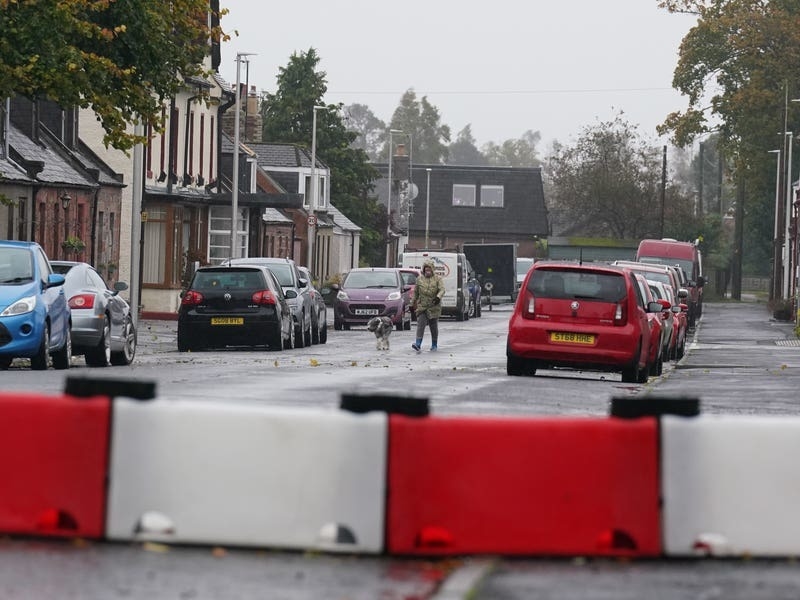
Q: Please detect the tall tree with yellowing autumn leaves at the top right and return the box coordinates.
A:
[659,0,800,272]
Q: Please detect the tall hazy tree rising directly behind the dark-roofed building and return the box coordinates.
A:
[383,89,450,164]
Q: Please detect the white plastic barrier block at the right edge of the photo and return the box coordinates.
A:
[661,415,800,556]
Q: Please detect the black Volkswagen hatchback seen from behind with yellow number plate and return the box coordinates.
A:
[178,265,295,352]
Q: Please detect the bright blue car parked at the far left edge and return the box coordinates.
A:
[0,240,72,370]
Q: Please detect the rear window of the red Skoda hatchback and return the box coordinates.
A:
[527,269,626,302]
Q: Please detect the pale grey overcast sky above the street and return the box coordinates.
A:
[220,0,695,153]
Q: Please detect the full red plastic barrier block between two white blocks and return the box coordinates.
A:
[386,415,661,556]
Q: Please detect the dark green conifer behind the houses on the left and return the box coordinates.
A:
[261,48,386,264]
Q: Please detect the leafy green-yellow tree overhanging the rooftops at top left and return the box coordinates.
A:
[0,0,227,150]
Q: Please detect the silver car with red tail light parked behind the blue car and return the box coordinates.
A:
[50,260,136,367]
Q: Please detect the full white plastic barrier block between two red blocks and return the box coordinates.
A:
[106,399,388,553]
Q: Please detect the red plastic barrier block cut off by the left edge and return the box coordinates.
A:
[0,393,111,538]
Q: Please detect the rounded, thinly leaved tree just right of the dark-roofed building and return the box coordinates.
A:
[547,116,676,239]
